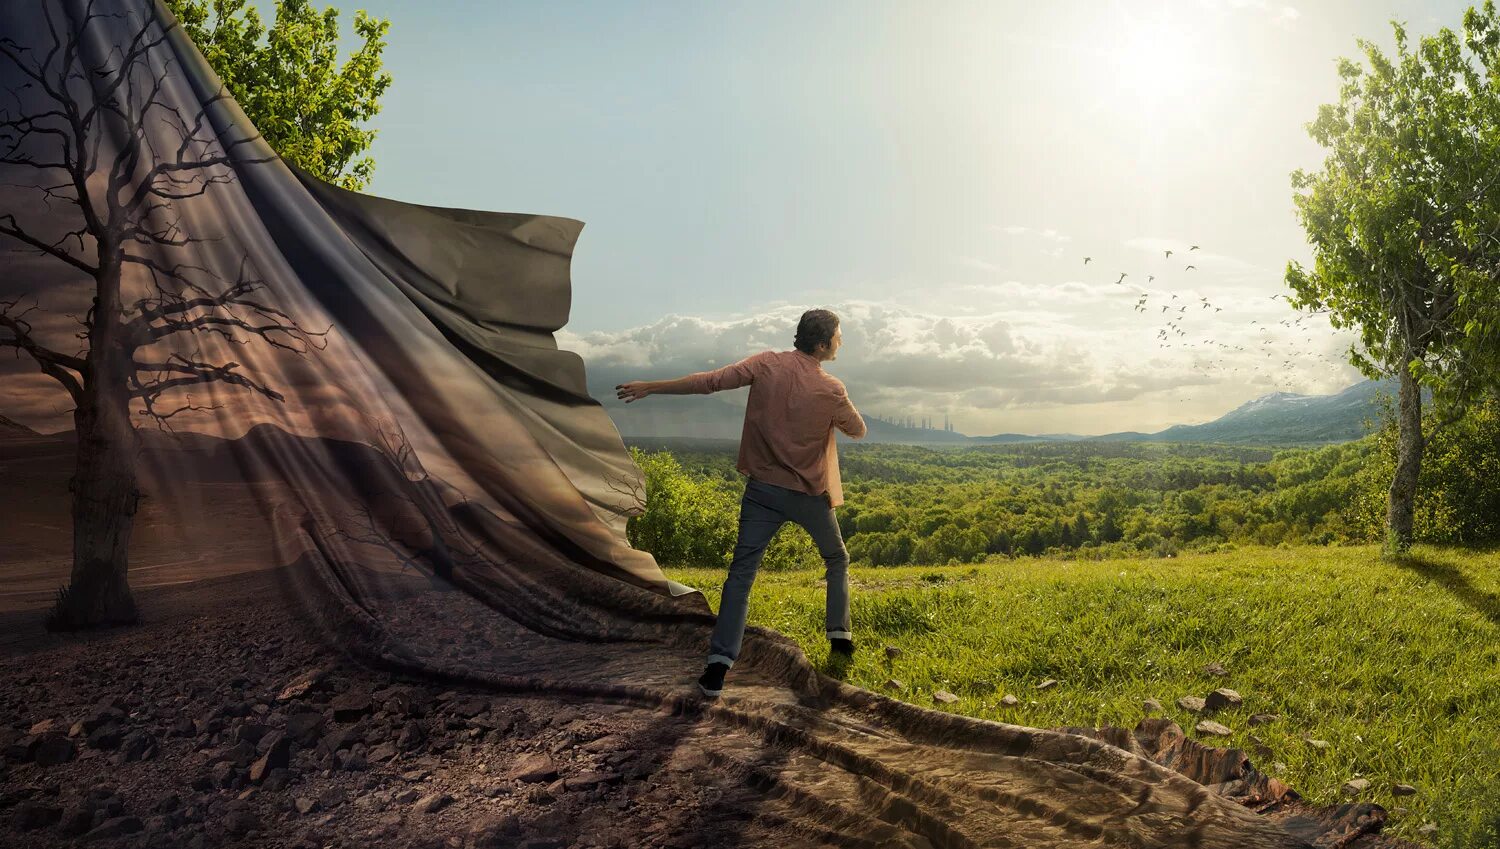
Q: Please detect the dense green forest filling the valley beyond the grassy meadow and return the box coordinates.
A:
[632,423,1500,569]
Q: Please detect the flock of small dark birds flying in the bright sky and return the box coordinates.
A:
[1083,245,1343,401]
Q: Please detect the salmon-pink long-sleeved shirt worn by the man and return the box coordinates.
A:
[687,350,866,507]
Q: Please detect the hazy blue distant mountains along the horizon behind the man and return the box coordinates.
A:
[605,380,1433,446]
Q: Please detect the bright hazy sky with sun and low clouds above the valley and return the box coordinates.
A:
[270,0,1469,435]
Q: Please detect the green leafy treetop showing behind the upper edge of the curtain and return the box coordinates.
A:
[167,0,392,189]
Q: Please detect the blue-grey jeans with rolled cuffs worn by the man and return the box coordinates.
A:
[708,479,851,666]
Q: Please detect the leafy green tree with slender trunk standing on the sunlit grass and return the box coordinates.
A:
[1286,0,1500,555]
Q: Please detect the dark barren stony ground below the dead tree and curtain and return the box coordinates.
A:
[0,573,846,849]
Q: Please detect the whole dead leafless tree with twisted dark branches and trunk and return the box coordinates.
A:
[0,0,327,629]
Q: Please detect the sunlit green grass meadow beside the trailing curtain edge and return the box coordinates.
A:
[668,546,1500,848]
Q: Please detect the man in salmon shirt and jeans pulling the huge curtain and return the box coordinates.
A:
[615,309,866,698]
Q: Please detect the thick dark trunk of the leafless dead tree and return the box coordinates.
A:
[47,264,141,630]
